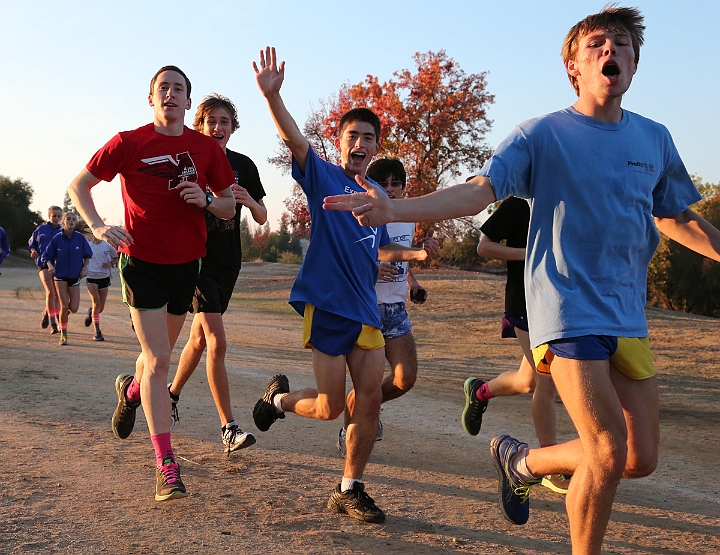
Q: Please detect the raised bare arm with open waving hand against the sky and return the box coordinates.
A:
[253,46,310,173]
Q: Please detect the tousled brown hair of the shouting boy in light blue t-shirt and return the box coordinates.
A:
[562,4,645,94]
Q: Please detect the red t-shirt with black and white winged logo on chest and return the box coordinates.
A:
[87,123,235,264]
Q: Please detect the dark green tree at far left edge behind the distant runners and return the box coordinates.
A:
[0,175,43,252]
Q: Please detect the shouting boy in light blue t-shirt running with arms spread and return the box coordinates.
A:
[325,5,720,553]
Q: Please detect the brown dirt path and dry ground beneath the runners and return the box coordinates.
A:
[0,264,720,555]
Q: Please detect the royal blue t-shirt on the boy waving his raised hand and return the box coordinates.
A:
[290,148,390,328]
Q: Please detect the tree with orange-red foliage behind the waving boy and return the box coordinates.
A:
[270,50,494,235]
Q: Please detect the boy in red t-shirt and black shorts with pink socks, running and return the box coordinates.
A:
[68,66,235,501]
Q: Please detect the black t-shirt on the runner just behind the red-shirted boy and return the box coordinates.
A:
[203,149,265,270]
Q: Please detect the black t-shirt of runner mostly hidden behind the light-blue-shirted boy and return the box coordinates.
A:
[480,197,530,318]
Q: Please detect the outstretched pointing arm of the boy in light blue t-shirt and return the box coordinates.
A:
[323,175,496,226]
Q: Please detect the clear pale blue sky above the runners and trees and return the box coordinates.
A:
[0,0,720,228]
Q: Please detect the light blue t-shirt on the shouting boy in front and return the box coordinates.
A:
[480,108,700,347]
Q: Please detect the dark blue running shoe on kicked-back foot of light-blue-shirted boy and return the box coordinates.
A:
[490,435,540,524]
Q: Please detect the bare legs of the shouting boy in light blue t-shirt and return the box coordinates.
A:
[516,356,659,555]
